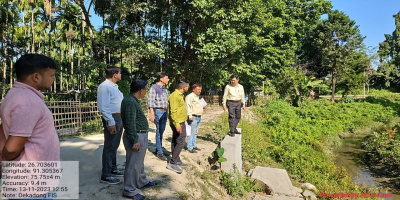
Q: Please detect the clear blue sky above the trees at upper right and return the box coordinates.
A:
[331,0,400,47]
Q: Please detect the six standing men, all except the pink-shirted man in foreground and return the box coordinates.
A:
[97,69,245,199]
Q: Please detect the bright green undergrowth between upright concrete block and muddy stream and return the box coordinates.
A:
[209,91,400,198]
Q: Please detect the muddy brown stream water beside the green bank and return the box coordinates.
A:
[334,135,400,200]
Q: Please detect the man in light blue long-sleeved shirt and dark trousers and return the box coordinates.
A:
[97,66,124,184]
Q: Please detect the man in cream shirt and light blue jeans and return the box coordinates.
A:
[185,83,203,153]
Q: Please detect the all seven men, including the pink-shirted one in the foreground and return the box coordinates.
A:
[0,54,245,199]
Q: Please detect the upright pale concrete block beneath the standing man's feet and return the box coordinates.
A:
[220,128,242,174]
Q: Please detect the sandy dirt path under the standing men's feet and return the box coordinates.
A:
[61,107,231,200]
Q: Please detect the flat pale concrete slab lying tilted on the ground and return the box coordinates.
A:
[251,166,297,197]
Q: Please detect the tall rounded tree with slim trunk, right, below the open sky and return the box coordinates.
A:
[302,10,368,101]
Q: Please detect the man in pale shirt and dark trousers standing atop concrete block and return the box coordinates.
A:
[222,75,245,137]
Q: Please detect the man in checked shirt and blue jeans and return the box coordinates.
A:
[147,72,169,161]
